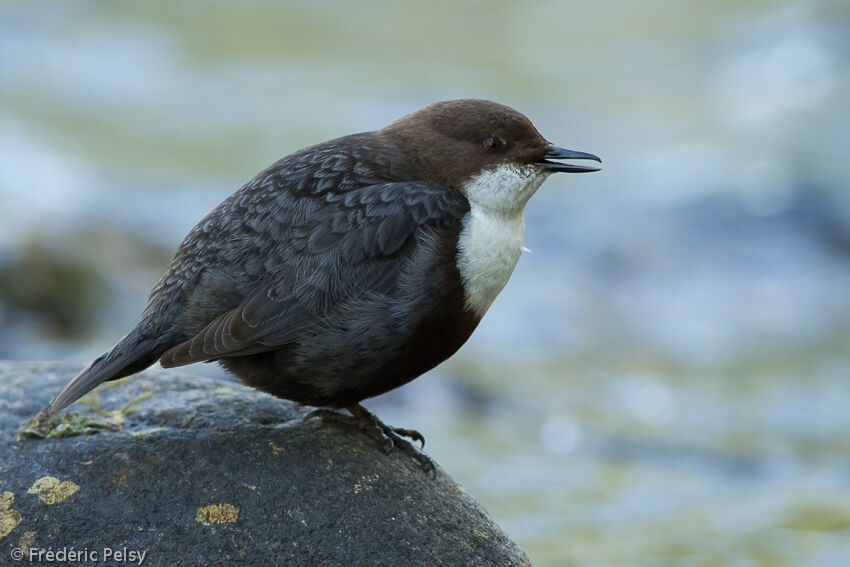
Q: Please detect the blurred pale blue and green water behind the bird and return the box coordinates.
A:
[0,0,850,567]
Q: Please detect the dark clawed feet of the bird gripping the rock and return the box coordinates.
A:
[304,404,437,478]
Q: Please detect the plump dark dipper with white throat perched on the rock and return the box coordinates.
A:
[47,99,601,474]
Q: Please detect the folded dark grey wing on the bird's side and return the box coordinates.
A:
[161,182,469,367]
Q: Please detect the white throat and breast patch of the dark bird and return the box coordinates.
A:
[457,164,548,317]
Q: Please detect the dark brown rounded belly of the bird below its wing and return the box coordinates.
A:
[220,286,480,407]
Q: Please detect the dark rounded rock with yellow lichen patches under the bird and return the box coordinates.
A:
[0,362,529,567]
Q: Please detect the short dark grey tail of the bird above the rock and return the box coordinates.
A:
[47,321,167,415]
